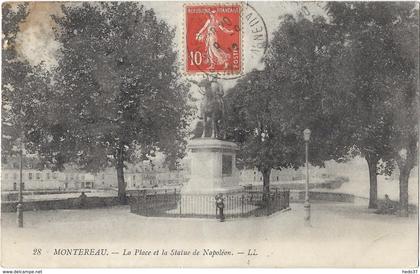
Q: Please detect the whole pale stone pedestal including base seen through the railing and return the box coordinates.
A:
[168,138,243,217]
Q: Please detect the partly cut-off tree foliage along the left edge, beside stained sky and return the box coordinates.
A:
[2,3,49,160]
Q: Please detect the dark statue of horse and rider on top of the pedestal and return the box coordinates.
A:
[189,78,226,139]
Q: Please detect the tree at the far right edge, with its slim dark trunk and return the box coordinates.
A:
[384,3,420,217]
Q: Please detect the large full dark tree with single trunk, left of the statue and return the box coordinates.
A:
[43,2,190,203]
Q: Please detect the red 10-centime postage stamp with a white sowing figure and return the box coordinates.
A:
[185,4,242,74]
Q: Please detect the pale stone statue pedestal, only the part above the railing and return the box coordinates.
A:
[181,138,242,195]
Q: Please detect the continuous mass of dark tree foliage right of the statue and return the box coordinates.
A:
[227,2,418,212]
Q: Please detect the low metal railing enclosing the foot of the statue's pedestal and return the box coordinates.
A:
[129,190,289,218]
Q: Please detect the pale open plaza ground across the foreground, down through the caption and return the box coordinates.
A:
[2,203,418,267]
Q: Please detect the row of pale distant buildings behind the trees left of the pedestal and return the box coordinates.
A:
[1,157,188,191]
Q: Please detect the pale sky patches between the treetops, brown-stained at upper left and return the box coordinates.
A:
[17,1,325,92]
